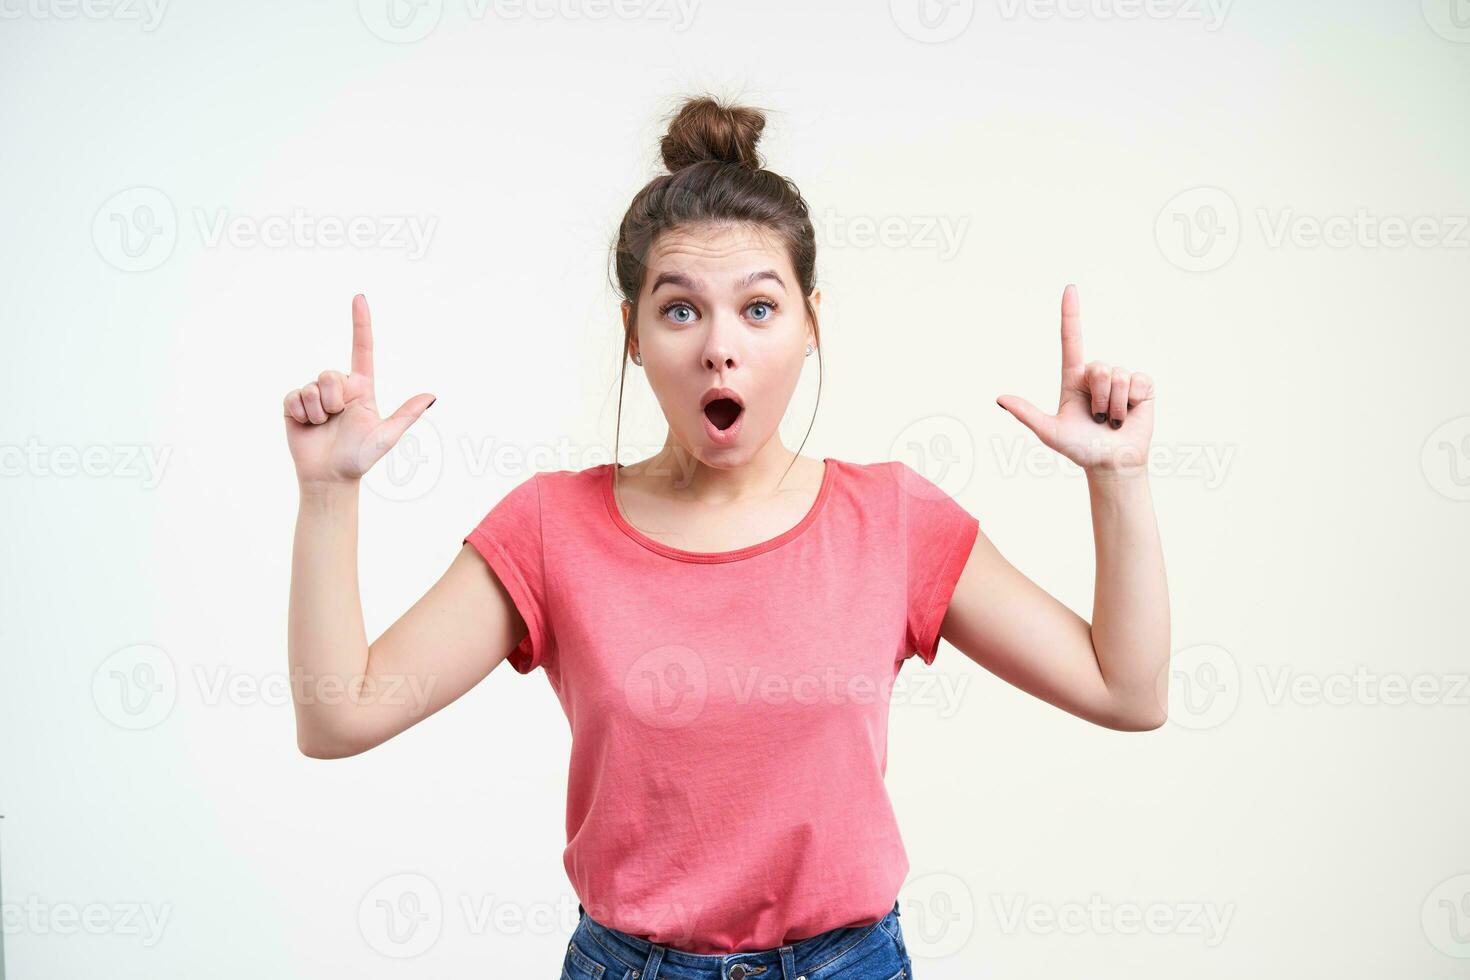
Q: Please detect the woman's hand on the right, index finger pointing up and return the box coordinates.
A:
[995,285,1154,472]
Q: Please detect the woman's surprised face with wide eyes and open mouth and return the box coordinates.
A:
[623,225,822,467]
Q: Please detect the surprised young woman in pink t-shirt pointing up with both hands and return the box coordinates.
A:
[285,98,1169,980]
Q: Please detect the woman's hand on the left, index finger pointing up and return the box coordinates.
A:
[277,292,434,489]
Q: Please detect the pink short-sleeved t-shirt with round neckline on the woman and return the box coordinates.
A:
[465,458,979,954]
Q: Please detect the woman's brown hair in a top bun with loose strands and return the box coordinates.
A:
[613,96,822,487]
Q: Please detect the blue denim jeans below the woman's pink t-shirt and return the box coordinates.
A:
[562,902,914,980]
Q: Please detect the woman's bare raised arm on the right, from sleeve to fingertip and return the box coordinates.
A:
[939,285,1169,732]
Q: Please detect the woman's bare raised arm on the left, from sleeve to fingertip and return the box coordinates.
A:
[285,295,526,758]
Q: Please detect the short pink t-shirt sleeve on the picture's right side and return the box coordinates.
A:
[895,461,980,664]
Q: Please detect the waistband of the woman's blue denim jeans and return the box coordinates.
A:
[576,899,898,980]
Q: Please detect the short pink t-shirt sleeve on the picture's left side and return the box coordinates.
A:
[465,475,551,674]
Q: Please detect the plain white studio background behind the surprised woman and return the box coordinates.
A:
[0,0,1470,980]
